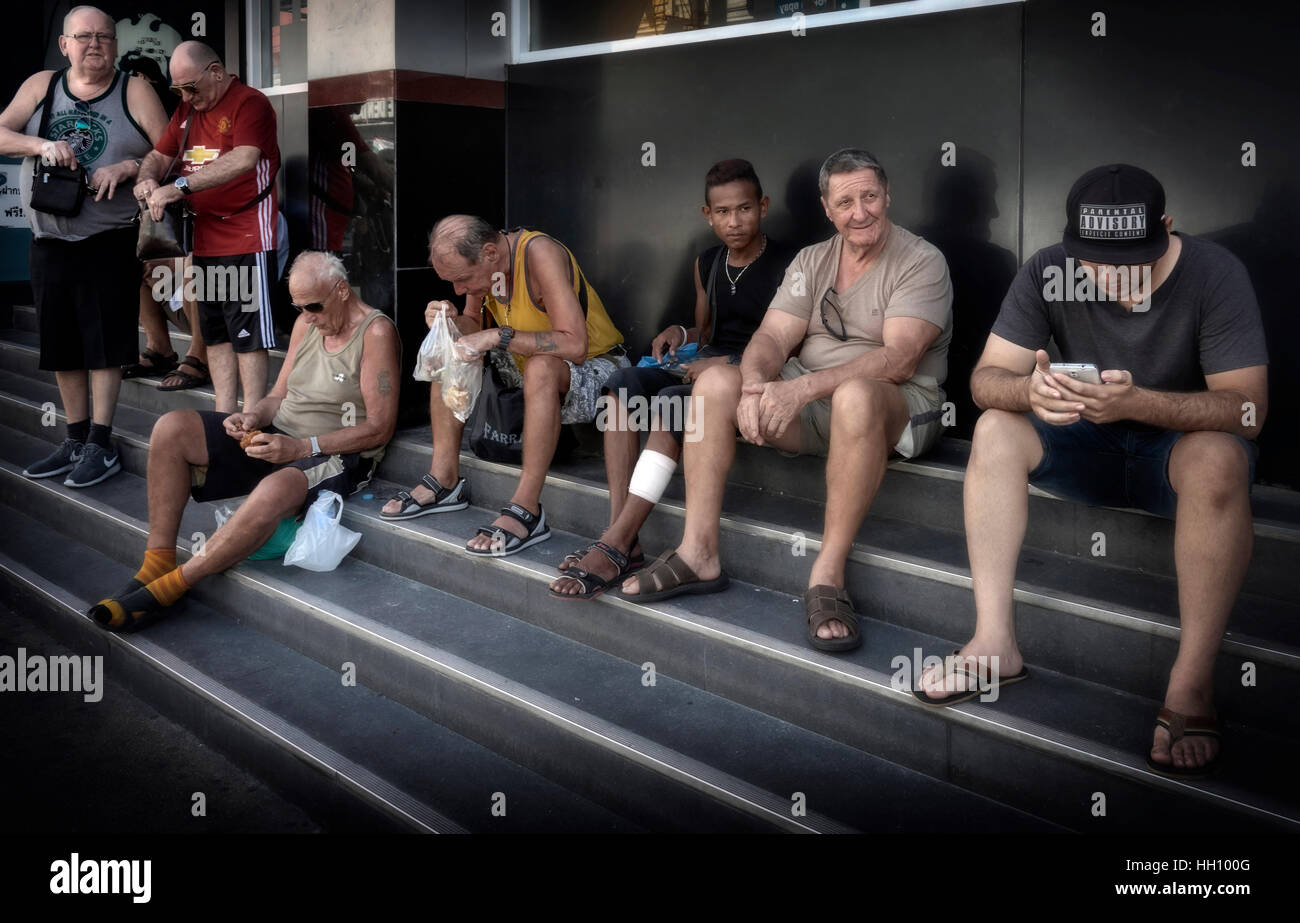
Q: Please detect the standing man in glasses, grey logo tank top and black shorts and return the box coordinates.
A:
[0,7,166,488]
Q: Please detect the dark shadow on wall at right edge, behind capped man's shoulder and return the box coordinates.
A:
[1199,182,1300,489]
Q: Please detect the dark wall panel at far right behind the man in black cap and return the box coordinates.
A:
[1024,0,1300,486]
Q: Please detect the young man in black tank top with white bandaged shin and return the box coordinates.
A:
[551,159,793,599]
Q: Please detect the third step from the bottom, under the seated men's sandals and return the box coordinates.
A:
[3,421,1300,832]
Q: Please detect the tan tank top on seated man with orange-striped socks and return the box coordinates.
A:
[272,311,393,459]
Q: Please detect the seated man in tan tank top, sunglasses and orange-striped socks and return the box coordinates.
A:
[90,251,400,632]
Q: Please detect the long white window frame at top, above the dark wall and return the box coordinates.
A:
[510,0,1024,64]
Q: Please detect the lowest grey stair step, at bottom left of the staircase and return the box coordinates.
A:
[0,498,634,833]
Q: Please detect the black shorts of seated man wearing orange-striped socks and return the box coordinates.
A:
[190,411,380,516]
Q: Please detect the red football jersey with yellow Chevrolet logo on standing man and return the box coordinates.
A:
[155,74,280,256]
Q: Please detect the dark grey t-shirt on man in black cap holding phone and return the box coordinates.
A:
[992,234,1269,391]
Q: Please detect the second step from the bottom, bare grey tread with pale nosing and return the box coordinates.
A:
[0,437,1052,832]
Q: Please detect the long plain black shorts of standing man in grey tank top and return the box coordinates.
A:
[27,225,140,372]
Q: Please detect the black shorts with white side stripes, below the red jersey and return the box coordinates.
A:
[192,250,277,352]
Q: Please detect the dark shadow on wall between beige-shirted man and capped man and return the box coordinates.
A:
[910,148,1017,439]
